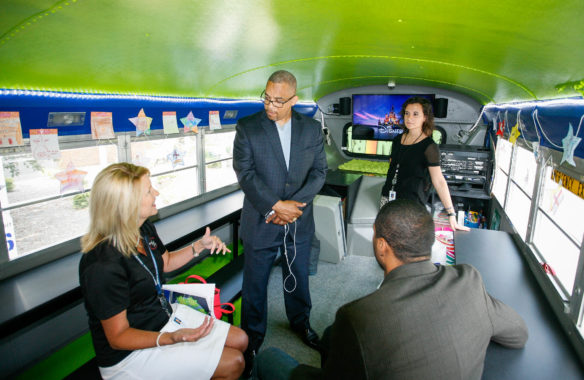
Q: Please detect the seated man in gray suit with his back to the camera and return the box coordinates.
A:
[257,200,527,379]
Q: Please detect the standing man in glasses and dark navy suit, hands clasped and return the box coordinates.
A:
[233,70,327,376]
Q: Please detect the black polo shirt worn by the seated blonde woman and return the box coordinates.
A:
[79,221,168,367]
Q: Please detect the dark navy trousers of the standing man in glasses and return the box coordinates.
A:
[241,227,313,351]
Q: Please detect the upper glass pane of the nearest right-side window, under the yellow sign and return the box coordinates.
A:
[539,167,584,243]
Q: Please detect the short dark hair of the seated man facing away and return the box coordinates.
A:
[375,199,435,263]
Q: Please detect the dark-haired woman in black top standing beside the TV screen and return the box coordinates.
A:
[380,97,469,231]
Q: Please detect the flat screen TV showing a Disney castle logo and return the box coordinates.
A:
[352,94,435,141]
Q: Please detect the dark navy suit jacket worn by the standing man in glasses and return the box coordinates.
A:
[233,110,327,249]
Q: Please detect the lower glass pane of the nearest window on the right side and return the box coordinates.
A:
[533,212,580,295]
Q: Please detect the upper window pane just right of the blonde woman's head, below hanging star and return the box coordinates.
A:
[132,135,197,175]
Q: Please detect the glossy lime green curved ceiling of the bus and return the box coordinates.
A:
[0,0,584,104]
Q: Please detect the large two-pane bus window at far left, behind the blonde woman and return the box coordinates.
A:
[0,145,117,260]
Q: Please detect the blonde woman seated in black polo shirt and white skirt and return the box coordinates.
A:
[79,163,248,380]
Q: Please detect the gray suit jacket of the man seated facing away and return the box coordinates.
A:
[293,261,527,380]
